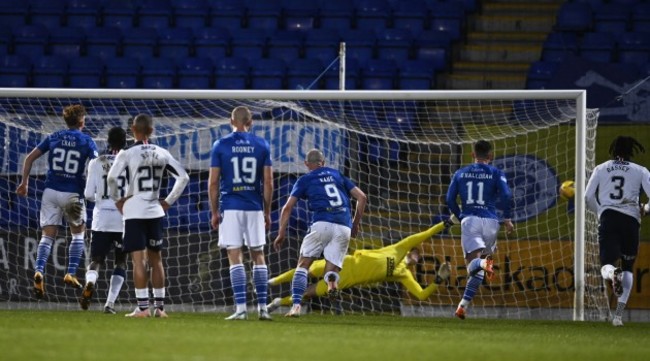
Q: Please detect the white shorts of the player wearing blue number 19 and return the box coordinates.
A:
[219,210,266,249]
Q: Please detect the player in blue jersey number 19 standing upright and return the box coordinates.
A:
[208,106,273,321]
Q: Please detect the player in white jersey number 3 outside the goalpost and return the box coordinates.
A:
[585,136,650,326]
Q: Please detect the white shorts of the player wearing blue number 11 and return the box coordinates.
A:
[460,216,499,255]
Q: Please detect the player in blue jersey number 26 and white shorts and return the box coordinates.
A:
[16,104,97,299]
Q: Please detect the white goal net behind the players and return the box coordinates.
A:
[0,89,608,319]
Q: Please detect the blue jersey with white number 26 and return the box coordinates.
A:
[36,129,98,197]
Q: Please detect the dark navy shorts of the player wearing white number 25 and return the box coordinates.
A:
[124,217,163,253]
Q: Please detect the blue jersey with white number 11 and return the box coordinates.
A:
[446,163,512,219]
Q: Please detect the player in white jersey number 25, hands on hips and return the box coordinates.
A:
[107,114,190,318]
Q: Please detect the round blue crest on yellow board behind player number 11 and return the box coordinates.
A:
[492,155,560,222]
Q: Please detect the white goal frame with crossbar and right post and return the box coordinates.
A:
[0,88,587,321]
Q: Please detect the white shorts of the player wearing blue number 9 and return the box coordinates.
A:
[300,222,352,268]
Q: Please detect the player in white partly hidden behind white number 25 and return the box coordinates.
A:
[79,127,128,314]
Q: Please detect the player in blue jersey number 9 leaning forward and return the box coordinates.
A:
[273,149,367,317]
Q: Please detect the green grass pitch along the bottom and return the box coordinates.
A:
[0,310,650,361]
